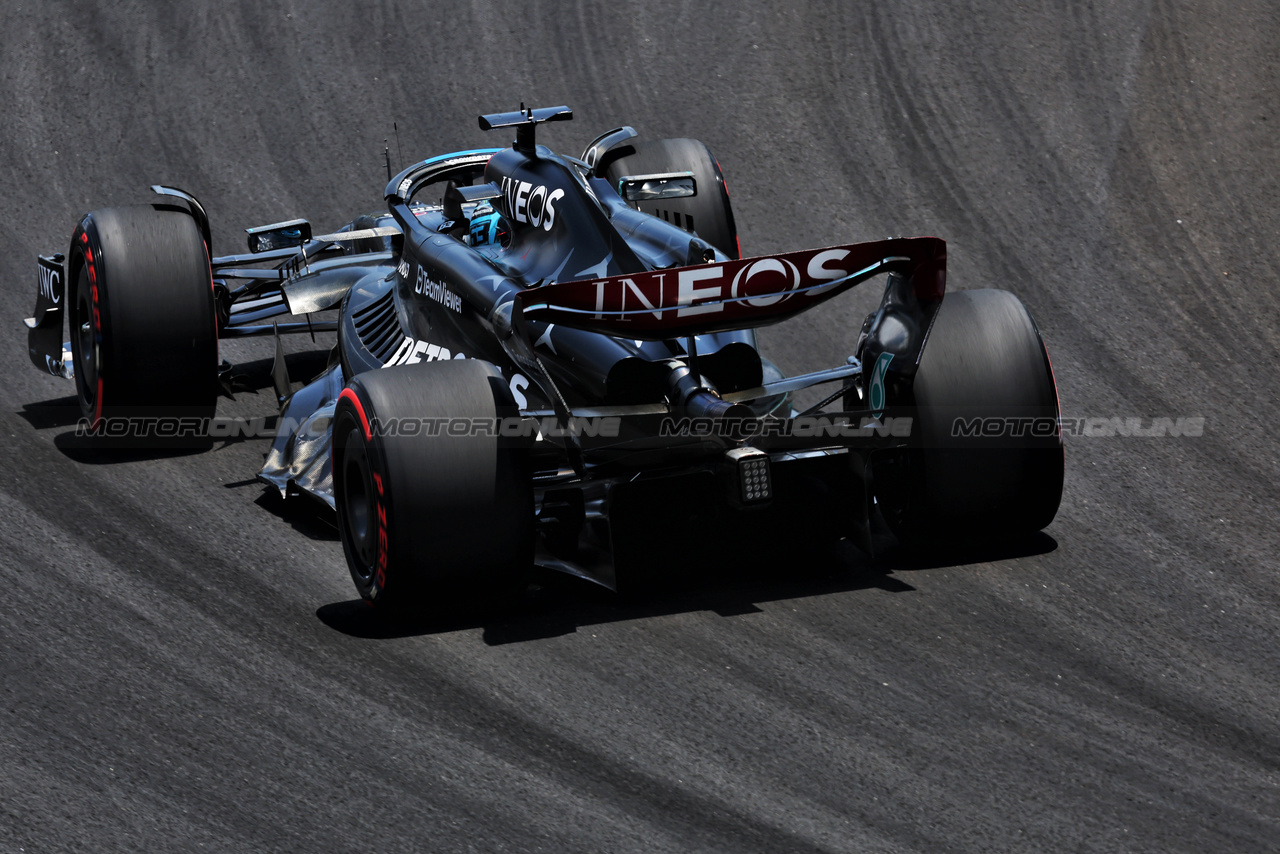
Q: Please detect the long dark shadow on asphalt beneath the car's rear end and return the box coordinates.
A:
[316,533,1057,647]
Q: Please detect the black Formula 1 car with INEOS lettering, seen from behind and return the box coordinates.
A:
[27,106,1062,609]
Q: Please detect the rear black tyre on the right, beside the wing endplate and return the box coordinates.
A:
[872,291,1062,549]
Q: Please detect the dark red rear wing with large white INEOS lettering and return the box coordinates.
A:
[520,237,947,341]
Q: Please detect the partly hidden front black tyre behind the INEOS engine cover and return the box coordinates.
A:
[605,140,742,259]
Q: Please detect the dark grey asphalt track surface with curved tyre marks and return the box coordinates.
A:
[0,0,1280,851]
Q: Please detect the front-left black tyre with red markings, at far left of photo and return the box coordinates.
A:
[68,205,218,428]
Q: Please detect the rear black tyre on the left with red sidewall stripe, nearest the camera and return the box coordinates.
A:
[333,360,534,613]
